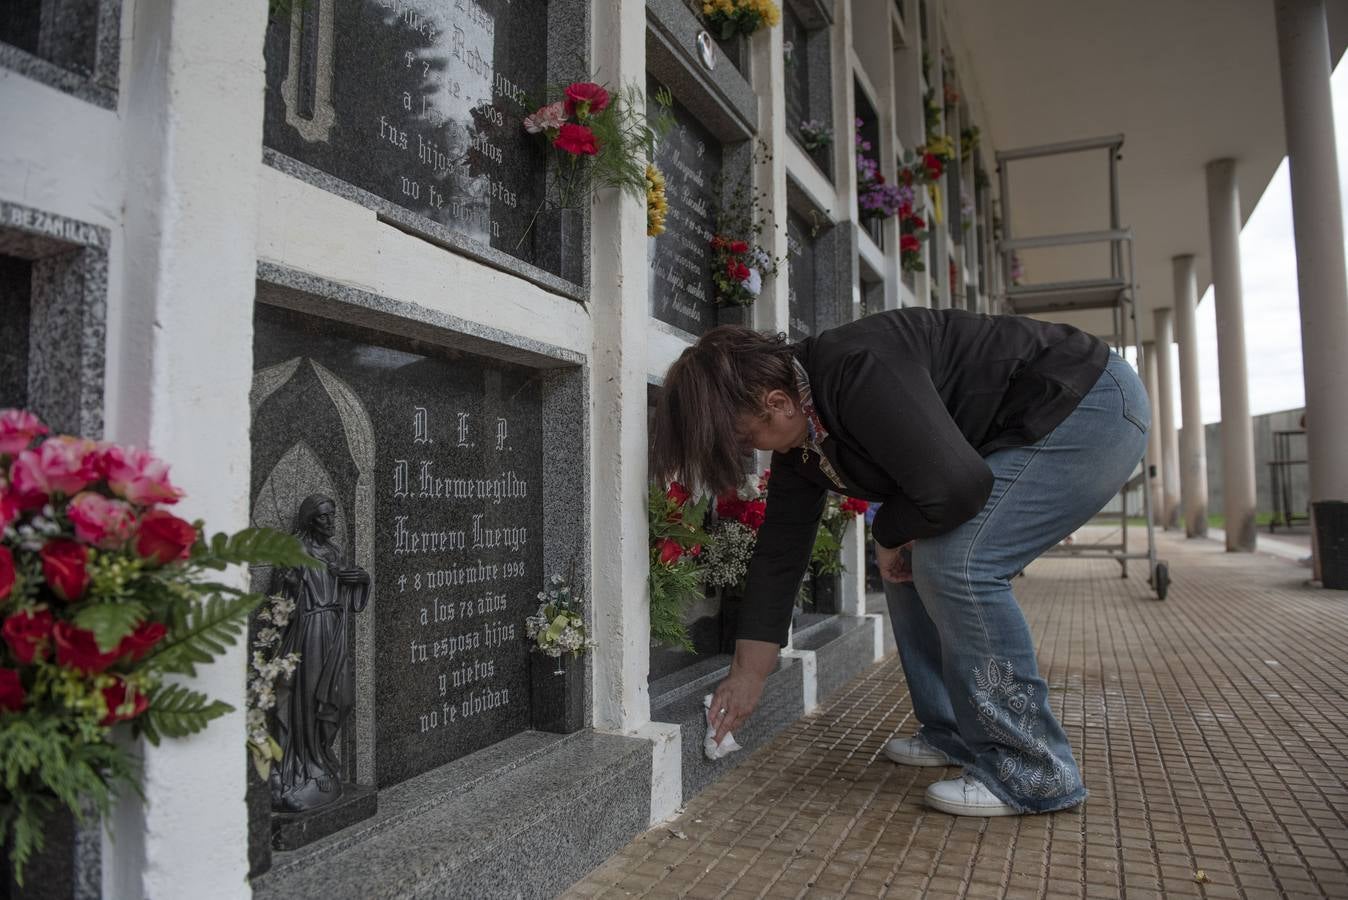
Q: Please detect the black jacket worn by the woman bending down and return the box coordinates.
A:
[737,309,1109,645]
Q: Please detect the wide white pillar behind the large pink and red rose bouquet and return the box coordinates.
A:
[104,0,267,900]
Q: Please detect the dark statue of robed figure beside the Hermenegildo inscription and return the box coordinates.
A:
[271,494,369,812]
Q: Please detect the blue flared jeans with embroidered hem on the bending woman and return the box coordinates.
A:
[884,353,1151,812]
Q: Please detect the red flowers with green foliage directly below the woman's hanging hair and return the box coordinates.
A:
[646,481,710,652]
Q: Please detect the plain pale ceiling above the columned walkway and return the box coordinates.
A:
[946,0,1348,340]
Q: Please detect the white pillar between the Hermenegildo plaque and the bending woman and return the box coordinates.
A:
[590,0,651,732]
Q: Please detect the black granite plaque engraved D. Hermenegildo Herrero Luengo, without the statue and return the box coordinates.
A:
[252,306,545,787]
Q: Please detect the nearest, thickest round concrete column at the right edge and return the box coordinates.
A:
[1275,0,1348,573]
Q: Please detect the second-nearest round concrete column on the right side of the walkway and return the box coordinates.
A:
[1206,159,1255,552]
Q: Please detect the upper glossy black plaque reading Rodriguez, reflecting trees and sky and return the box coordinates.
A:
[264,0,577,279]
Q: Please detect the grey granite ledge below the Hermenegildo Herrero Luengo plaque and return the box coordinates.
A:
[252,730,651,900]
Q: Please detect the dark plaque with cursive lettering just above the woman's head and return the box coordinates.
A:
[647,81,721,334]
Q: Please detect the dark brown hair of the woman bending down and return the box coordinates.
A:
[651,325,797,493]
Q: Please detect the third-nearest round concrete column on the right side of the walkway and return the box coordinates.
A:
[1173,256,1208,538]
